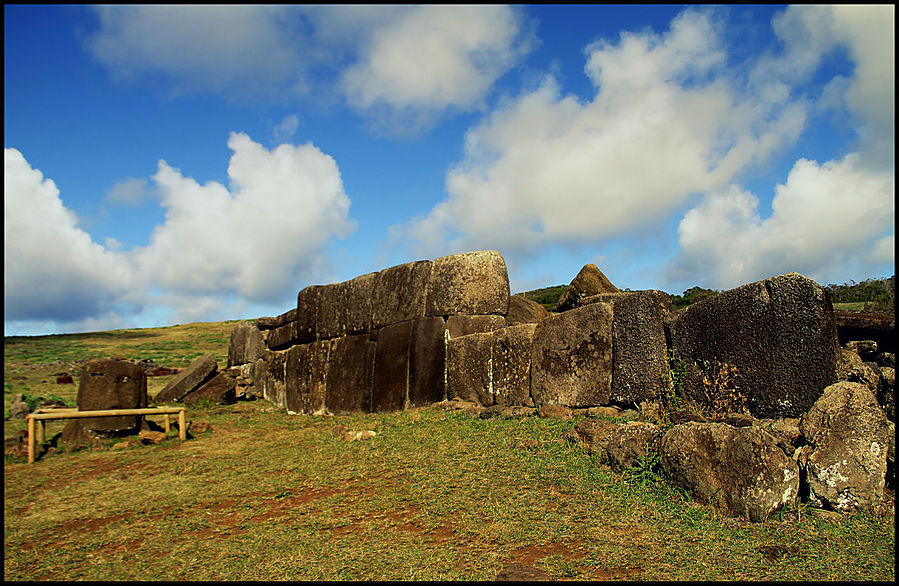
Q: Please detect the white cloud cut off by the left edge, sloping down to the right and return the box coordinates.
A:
[3,148,132,321]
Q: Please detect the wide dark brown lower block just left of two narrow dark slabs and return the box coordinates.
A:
[325,334,377,413]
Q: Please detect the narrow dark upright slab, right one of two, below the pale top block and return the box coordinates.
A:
[409,317,446,407]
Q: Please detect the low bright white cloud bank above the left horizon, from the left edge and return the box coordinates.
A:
[4,133,355,331]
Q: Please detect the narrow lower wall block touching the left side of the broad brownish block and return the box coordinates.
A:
[491,323,537,406]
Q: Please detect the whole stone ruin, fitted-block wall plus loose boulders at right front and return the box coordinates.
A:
[214,251,895,520]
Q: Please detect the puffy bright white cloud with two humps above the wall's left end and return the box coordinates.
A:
[135,133,354,302]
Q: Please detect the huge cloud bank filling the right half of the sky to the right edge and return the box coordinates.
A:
[400,6,895,287]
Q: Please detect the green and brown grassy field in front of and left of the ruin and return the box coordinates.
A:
[4,322,895,580]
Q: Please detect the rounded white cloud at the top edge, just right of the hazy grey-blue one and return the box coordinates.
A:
[341,5,529,132]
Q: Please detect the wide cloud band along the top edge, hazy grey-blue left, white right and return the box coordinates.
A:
[86,5,533,129]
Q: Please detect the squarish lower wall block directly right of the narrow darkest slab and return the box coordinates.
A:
[446,332,493,407]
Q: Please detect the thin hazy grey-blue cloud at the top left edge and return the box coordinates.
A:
[87,5,303,99]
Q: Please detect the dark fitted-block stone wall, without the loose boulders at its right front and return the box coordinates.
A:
[228,251,852,417]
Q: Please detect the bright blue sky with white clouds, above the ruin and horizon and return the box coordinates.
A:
[4,5,895,335]
